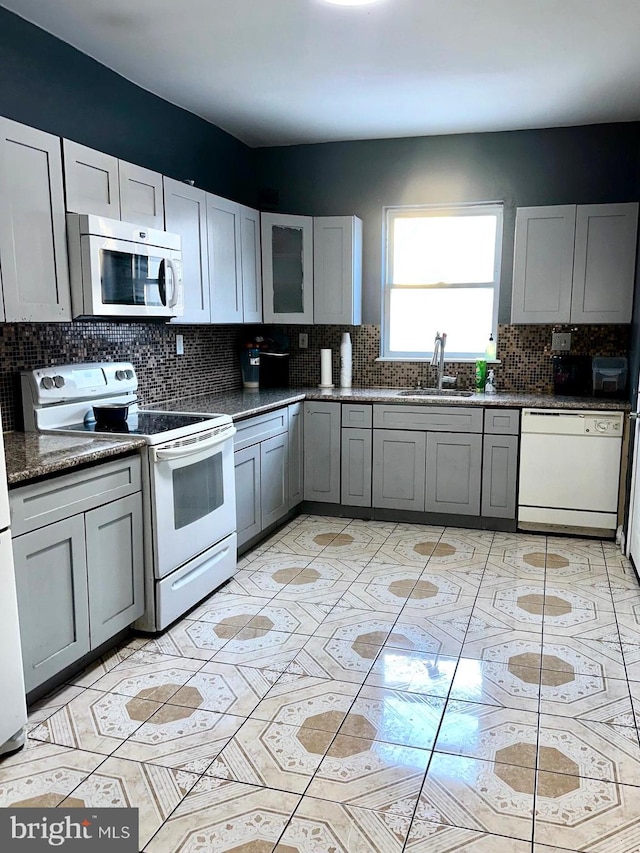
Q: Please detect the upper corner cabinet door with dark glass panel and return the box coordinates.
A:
[260,213,313,323]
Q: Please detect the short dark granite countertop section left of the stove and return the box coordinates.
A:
[4,432,145,486]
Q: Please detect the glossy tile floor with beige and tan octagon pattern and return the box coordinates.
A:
[0,516,640,853]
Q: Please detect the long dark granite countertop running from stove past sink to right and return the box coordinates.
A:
[148,388,630,420]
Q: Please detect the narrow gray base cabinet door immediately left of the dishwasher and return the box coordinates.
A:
[482,435,518,518]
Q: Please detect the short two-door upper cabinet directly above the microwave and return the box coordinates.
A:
[62,139,164,231]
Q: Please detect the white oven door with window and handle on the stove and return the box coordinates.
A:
[149,426,236,578]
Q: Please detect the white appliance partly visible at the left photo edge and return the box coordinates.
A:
[0,410,27,755]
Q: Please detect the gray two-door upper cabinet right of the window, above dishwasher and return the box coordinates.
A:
[511,202,638,323]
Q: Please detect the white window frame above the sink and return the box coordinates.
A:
[379,201,504,361]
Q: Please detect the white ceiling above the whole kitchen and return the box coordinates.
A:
[1,0,640,146]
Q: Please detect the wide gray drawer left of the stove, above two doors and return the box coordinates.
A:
[9,456,141,536]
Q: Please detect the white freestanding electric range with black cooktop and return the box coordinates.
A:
[21,362,237,631]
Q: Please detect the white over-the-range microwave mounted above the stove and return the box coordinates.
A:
[67,213,184,320]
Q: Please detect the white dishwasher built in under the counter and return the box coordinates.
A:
[518,409,624,536]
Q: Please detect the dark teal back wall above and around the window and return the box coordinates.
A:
[257,123,640,323]
